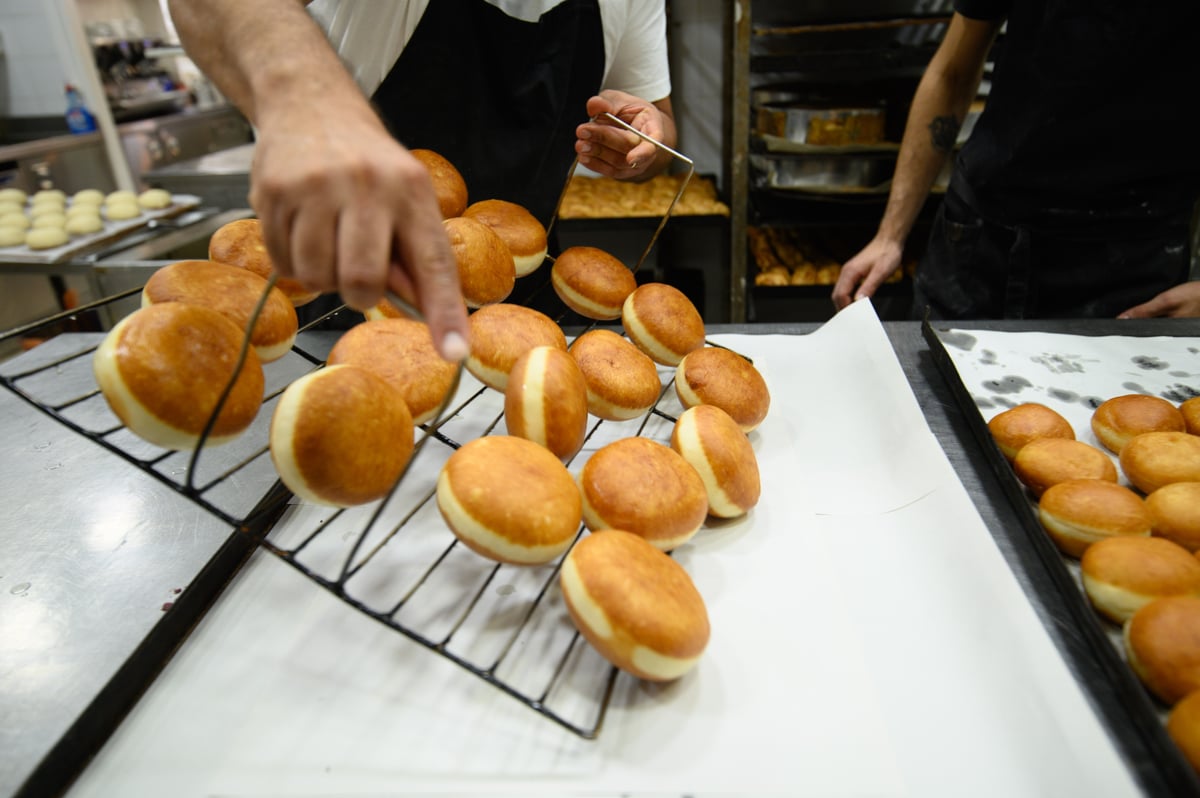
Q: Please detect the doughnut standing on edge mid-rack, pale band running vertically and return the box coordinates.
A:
[504,347,588,461]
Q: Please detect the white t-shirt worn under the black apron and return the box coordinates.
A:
[308,0,671,102]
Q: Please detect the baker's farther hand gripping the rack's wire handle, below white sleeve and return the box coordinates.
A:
[575,90,676,180]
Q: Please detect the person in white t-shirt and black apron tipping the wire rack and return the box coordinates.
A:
[170,0,676,360]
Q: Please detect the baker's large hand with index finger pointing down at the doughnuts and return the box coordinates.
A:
[250,98,467,360]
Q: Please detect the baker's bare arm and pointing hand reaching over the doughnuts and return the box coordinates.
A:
[170,0,467,360]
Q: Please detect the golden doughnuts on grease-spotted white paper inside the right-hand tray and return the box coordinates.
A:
[926,321,1200,770]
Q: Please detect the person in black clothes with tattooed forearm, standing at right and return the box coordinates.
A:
[833,0,1200,319]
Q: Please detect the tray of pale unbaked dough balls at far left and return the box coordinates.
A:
[0,188,200,264]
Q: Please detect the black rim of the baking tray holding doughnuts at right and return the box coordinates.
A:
[922,319,1200,796]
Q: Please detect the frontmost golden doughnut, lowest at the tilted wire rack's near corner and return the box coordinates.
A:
[559,529,710,682]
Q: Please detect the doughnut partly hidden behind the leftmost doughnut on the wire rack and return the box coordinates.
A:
[142,260,299,362]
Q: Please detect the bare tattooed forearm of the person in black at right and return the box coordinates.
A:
[877,18,995,245]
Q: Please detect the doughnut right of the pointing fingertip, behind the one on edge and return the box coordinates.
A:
[467,302,566,394]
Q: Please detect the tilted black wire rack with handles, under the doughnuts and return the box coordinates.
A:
[0,123,691,739]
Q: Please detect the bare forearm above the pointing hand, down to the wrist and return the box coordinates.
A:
[169,0,367,126]
